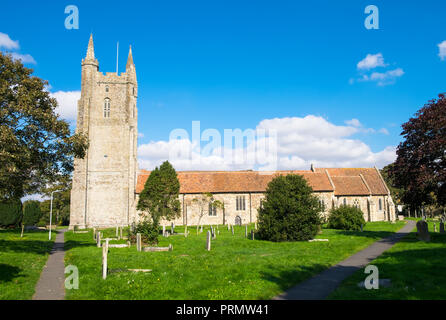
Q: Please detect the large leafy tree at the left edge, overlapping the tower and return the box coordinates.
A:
[0,52,88,200]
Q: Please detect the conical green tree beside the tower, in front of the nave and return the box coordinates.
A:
[137,161,181,226]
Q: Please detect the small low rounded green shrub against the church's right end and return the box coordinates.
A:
[327,205,365,231]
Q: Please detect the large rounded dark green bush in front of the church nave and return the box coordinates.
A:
[258,174,321,242]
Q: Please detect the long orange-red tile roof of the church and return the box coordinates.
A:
[136,168,388,196]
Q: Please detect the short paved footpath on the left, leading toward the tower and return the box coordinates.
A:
[33,229,67,300]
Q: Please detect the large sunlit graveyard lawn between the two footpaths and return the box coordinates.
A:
[65,222,404,300]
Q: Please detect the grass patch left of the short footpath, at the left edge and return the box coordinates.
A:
[0,230,56,300]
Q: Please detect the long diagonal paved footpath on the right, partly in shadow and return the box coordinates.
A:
[273,220,416,300]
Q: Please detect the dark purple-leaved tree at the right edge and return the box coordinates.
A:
[389,94,446,208]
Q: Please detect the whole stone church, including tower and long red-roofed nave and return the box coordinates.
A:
[70,36,395,229]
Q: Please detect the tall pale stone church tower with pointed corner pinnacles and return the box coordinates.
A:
[70,36,138,228]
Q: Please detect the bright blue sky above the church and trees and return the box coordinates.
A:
[0,0,446,167]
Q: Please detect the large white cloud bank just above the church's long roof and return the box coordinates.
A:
[138,115,396,170]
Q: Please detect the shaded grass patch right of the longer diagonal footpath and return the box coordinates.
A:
[329,219,446,300]
